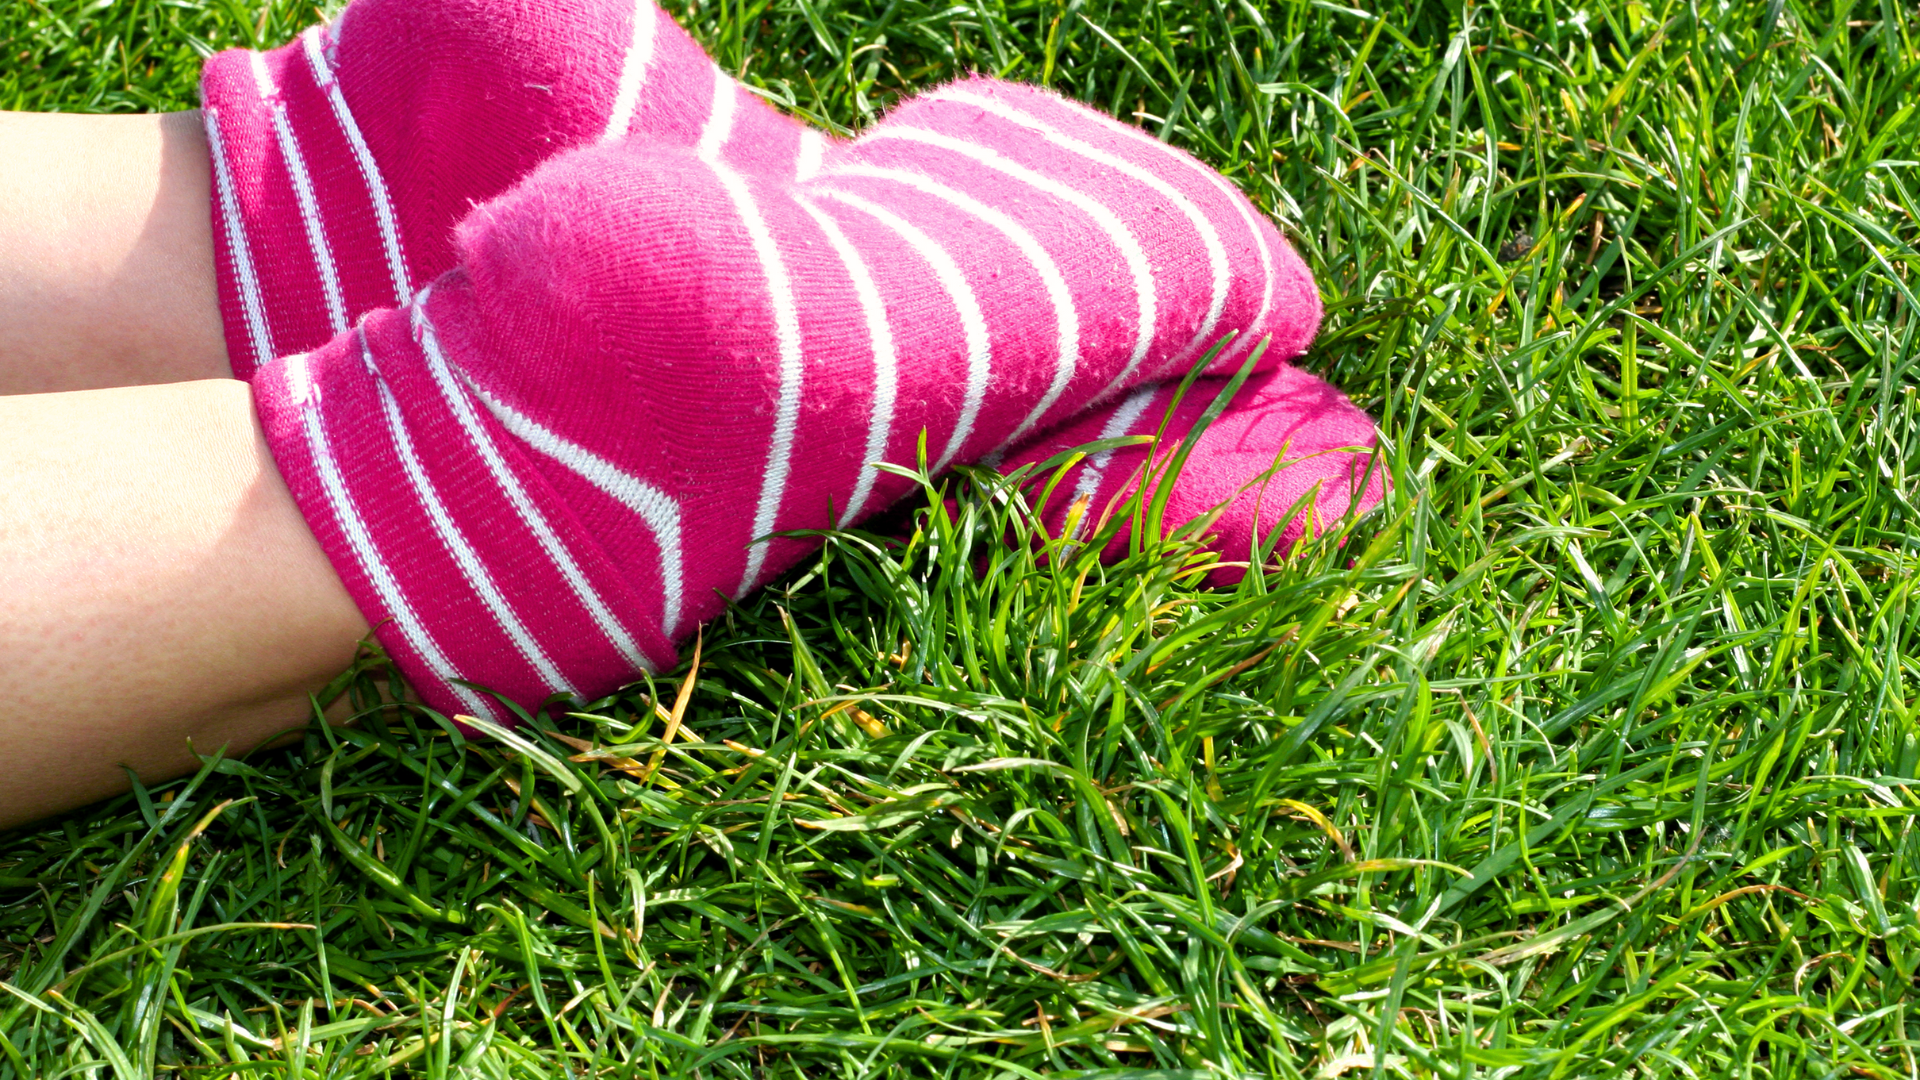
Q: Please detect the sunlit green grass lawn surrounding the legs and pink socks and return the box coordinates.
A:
[0,0,1920,1080]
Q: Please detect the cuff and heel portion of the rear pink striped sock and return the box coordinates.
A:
[202,0,826,379]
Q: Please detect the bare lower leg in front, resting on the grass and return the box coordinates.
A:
[0,379,369,828]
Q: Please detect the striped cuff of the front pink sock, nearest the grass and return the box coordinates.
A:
[253,286,674,726]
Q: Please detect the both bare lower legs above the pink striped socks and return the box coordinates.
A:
[0,111,367,828]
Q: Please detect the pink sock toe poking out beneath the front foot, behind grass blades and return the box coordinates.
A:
[1002,365,1388,584]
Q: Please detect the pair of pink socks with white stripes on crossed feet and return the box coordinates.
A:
[205,0,1379,721]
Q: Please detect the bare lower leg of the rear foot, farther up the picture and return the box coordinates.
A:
[0,111,232,394]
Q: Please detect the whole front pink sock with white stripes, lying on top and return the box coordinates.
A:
[255,73,1319,719]
